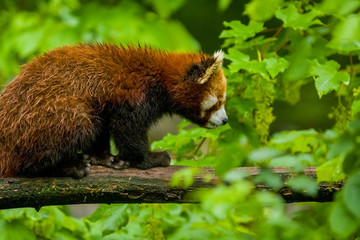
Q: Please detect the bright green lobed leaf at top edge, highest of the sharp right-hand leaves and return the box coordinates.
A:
[275,3,323,30]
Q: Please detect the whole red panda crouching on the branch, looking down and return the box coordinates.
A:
[0,44,228,178]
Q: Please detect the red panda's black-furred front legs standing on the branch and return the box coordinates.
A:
[90,86,171,169]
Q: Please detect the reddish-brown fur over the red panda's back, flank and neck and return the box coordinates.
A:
[0,44,225,177]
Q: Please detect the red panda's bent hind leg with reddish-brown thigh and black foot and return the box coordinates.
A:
[14,98,101,178]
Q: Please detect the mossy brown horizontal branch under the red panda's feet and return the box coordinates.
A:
[0,166,344,209]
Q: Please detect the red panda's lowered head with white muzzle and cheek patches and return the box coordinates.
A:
[176,51,228,128]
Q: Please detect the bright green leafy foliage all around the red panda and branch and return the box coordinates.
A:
[0,0,360,240]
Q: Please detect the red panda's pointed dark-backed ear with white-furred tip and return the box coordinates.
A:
[186,50,224,84]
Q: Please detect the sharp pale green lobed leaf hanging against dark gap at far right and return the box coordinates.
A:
[312,60,350,98]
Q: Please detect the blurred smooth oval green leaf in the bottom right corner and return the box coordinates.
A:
[329,202,359,238]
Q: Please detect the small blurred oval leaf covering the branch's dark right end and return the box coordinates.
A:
[287,176,318,197]
